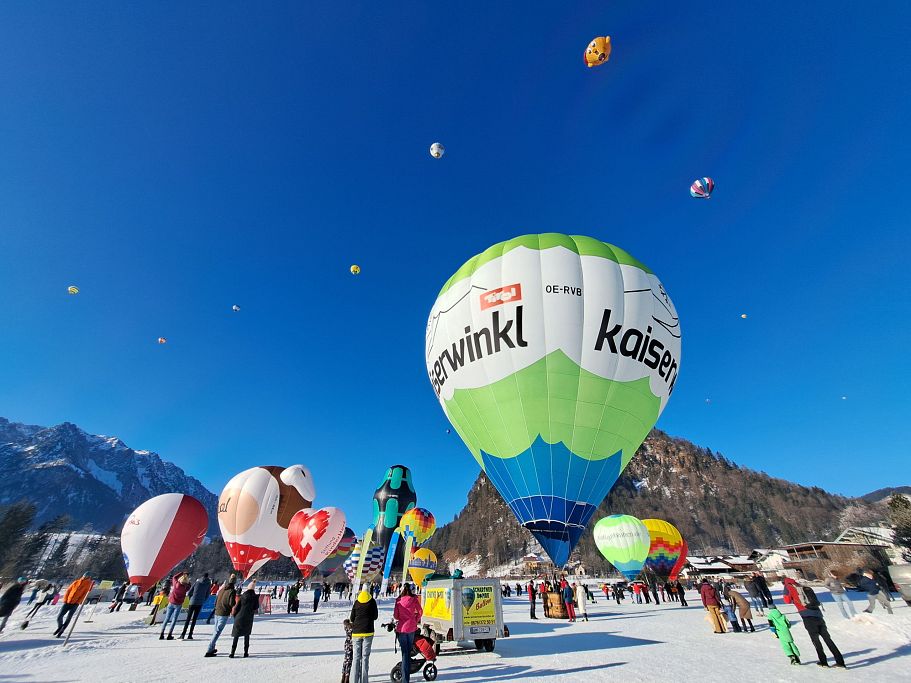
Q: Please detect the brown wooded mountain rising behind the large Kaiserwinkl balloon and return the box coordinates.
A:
[428,430,887,570]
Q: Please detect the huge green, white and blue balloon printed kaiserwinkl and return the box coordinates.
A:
[426,233,680,566]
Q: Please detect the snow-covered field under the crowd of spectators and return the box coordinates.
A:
[0,590,911,683]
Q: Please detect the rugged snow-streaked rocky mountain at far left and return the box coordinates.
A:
[0,417,218,532]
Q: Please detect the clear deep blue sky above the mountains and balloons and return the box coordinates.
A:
[0,1,911,528]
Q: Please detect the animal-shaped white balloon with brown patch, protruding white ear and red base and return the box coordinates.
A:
[218,465,316,578]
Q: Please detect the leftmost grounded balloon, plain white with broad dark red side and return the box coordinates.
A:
[120,493,209,591]
